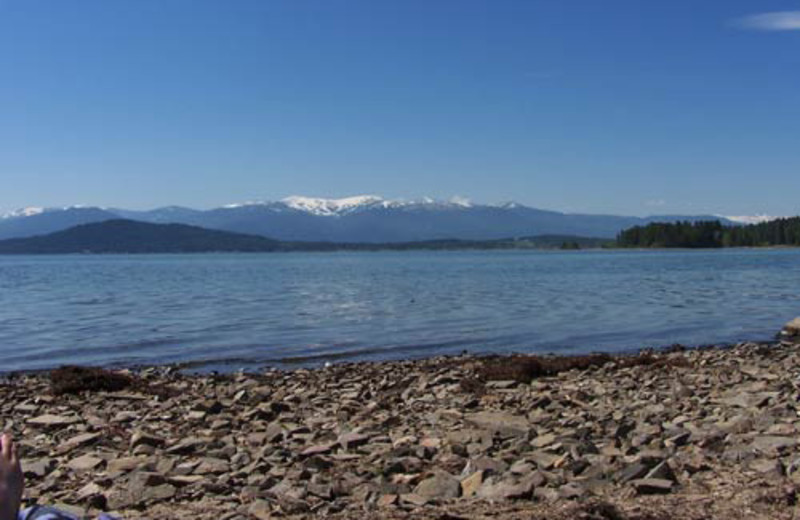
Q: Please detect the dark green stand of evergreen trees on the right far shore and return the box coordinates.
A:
[617,217,800,248]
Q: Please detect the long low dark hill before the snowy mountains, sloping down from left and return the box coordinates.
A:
[0,219,611,254]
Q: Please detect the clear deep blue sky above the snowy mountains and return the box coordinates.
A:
[0,0,800,215]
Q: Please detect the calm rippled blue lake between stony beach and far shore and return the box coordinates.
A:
[0,250,800,371]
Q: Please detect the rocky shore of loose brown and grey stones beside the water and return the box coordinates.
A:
[0,320,800,520]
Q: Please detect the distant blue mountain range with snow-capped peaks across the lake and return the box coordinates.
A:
[0,195,735,243]
